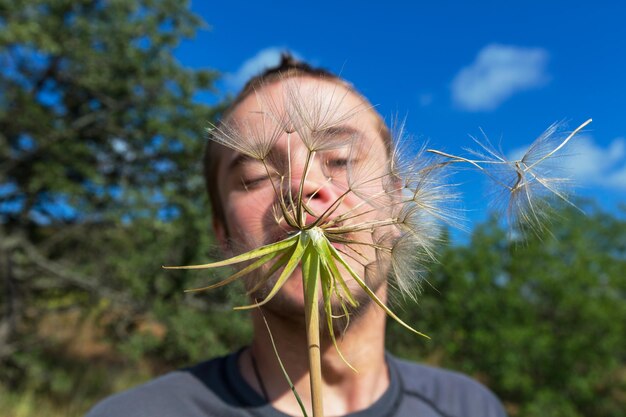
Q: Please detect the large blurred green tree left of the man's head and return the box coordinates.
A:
[0,0,246,406]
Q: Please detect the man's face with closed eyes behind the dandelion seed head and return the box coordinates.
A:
[215,77,389,315]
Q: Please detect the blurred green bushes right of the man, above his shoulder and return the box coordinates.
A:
[389,202,626,416]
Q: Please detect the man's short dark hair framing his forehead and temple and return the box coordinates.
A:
[204,52,391,231]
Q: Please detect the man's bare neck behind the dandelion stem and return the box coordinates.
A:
[239,289,389,416]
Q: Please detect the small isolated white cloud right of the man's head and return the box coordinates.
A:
[452,44,549,111]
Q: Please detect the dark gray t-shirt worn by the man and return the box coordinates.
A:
[87,351,506,417]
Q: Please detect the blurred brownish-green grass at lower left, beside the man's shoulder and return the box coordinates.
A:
[0,310,169,417]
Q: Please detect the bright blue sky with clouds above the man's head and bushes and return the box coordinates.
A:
[177,1,626,228]
